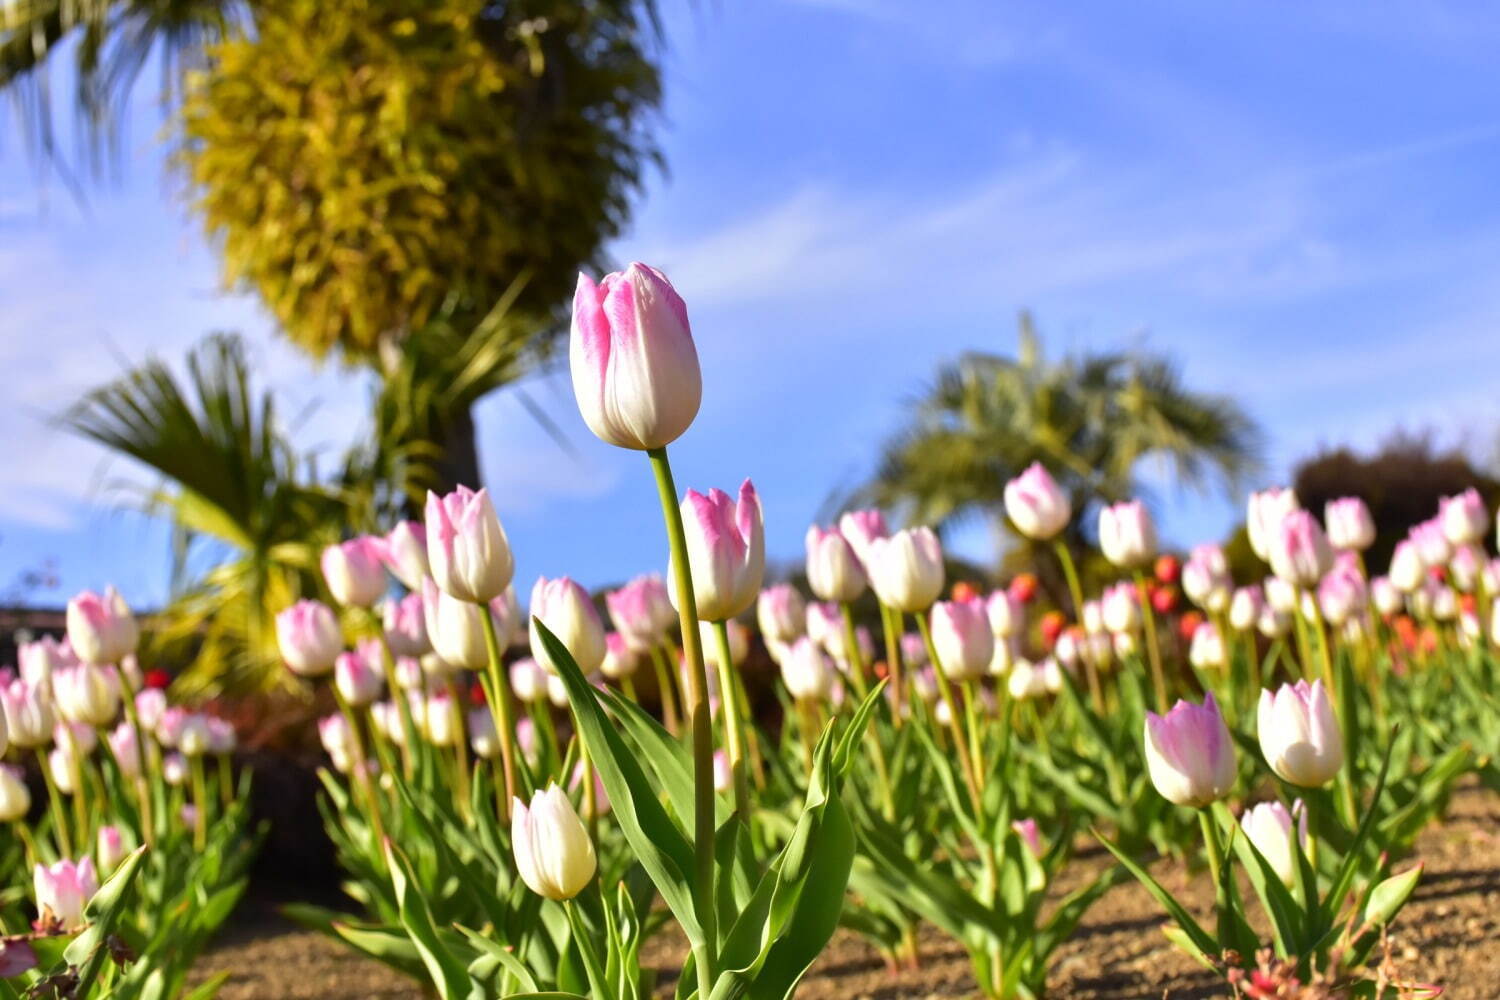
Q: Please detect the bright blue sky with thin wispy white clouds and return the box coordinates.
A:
[0,0,1500,606]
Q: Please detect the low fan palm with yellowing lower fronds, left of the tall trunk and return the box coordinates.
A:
[62,336,354,694]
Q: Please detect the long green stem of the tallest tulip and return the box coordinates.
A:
[647,448,719,1000]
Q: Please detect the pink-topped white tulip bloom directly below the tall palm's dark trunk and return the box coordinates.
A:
[426,486,516,604]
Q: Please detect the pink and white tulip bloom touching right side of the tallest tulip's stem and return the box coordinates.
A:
[669,480,765,622]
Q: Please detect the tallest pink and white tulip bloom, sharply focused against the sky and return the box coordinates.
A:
[569,262,704,451]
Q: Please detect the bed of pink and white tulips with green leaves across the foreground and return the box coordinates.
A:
[8,265,1500,1000]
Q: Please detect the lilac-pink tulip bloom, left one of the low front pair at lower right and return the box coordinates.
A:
[1146,694,1235,808]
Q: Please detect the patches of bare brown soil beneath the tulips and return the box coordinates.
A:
[200,787,1500,1000]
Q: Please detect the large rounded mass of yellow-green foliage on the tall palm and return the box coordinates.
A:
[180,0,659,355]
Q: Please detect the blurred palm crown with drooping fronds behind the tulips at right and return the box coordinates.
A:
[854,313,1260,578]
